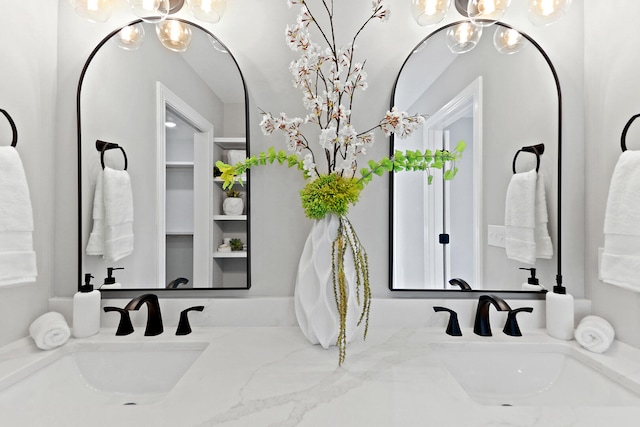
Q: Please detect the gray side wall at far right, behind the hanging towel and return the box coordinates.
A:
[584,0,640,347]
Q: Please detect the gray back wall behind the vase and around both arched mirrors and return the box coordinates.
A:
[54,0,584,297]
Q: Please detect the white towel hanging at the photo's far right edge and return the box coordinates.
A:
[600,150,640,292]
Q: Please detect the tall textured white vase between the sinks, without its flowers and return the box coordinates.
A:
[294,215,364,349]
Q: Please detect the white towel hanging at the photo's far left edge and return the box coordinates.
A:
[0,146,38,286]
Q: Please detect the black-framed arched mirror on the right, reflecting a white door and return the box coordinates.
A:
[390,22,562,291]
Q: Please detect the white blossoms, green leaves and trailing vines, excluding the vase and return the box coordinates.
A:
[216,0,464,364]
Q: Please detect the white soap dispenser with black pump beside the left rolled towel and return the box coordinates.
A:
[73,273,100,338]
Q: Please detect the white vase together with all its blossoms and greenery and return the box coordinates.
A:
[216,0,464,364]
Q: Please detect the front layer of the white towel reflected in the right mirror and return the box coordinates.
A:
[504,170,538,264]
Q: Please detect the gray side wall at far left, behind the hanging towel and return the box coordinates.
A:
[0,0,57,346]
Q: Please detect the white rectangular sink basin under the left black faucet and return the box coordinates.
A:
[0,342,208,406]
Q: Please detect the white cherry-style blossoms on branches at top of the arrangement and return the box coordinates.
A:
[260,0,424,178]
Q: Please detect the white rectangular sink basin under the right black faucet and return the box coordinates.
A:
[432,342,640,406]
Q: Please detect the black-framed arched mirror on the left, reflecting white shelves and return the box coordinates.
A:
[77,20,251,295]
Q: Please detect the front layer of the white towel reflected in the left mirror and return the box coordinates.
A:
[102,167,133,261]
